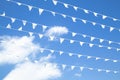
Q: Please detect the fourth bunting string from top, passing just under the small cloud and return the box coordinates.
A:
[1,24,120,52]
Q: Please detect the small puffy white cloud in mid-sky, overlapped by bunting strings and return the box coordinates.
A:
[45,26,68,37]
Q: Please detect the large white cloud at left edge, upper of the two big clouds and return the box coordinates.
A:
[0,36,40,64]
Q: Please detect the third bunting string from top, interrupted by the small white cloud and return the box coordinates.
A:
[0,12,120,45]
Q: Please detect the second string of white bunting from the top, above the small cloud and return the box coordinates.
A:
[3,0,120,32]
